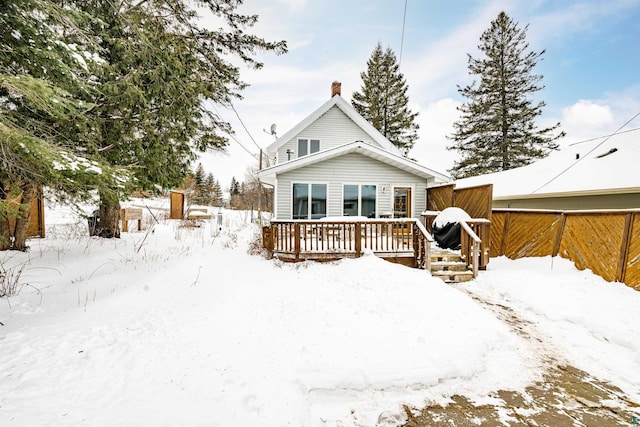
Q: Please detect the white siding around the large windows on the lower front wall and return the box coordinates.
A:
[276,153,427,219]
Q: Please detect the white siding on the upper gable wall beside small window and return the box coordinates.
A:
[278,106,380,163]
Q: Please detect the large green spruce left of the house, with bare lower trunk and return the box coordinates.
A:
[76,0,286,237]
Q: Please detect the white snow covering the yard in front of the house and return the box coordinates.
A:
[0,201,640,427]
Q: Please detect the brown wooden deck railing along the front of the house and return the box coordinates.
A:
[263,218,433,268]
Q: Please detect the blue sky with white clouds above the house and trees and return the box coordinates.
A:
[198,0,640,187]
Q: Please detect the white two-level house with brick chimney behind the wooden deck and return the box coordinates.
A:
[258,82,450,220]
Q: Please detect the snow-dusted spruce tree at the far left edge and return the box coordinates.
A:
[0,0,126,250]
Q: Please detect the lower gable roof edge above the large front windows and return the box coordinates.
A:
[258,140,451,184]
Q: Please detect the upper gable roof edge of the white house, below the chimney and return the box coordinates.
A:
[267,95,401,155]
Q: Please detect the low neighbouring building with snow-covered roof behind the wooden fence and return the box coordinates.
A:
[456,128,640,210]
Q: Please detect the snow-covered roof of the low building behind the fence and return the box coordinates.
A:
[456,128,640,200]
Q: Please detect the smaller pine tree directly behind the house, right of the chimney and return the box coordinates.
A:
[351,43,419,156]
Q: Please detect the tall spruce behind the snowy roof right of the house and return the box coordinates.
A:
[448,12,564,178]
